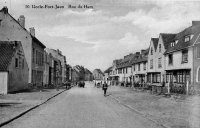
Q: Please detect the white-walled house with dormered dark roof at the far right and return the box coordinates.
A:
[165,22,200,93]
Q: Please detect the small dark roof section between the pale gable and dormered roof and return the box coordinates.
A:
[160,33,176,49]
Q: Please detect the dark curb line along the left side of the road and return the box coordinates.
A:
[0,90,67,127]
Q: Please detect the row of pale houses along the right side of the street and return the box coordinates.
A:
[105,21,200,92]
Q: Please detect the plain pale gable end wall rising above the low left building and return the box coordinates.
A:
[0,12,32,83]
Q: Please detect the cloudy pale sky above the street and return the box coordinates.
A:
[0,0,200,70]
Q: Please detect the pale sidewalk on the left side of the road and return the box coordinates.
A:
[0,89,65,127]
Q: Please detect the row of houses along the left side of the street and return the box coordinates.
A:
[0,7,71,94]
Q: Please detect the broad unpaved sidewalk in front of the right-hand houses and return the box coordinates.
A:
[108,86,200,128]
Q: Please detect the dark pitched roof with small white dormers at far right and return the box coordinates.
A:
[165,25,200,54]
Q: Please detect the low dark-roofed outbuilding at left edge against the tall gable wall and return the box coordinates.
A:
[0,41,29,94]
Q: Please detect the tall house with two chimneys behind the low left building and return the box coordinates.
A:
[0,7,45,85]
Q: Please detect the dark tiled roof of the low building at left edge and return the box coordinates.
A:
[0,41,16,71]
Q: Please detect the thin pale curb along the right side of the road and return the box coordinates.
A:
[110,94,171,128]
